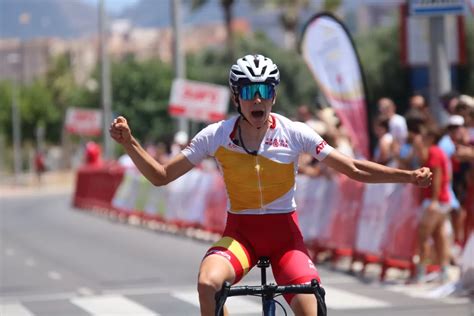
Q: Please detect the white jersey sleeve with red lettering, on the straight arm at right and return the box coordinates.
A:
[295,122,334,161]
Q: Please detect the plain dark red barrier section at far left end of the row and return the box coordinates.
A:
[73,165,124,210]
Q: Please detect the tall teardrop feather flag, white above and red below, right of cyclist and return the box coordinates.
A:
[301,13,369,158]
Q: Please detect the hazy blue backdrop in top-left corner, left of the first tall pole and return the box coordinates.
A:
[0,0,98,39]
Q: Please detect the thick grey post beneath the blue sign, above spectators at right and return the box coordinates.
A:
[429,15,451,126]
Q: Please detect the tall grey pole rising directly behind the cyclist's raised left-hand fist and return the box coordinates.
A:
[99,0,112,159]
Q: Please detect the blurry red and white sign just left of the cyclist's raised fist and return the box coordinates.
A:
[65,108,102,136]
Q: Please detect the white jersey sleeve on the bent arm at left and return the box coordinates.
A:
[181,124,218,165]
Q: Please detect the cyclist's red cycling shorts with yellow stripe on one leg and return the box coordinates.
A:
[205,211,320,303]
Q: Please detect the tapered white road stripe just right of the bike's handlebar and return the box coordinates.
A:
[324,286,392,310]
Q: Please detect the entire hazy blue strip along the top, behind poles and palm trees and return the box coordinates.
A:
[0,0,328,42]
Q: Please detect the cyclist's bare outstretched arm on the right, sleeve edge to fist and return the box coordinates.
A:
[323,150,433,187]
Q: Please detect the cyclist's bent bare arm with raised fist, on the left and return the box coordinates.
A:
[109,116,194,186]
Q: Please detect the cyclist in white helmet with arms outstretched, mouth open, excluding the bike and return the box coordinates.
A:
[110,55,432,315]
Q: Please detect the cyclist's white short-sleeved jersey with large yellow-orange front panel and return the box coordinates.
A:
[182,113,333,214]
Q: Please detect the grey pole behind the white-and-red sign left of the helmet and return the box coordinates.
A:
[171,0,189,135]
